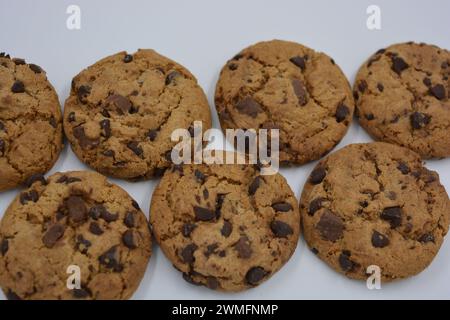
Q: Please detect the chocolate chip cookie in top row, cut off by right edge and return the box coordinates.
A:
[354,42,450,158]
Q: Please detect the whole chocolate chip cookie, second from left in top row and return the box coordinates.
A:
[64,50,211,179]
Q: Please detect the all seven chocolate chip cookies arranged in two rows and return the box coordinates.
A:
[0,40,450,299]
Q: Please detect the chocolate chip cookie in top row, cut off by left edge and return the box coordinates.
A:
[0,53,63,192]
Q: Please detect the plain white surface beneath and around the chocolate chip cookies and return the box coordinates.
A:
[0,0,450,299]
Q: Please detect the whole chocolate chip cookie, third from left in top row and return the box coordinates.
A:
[215,40,354,164]
